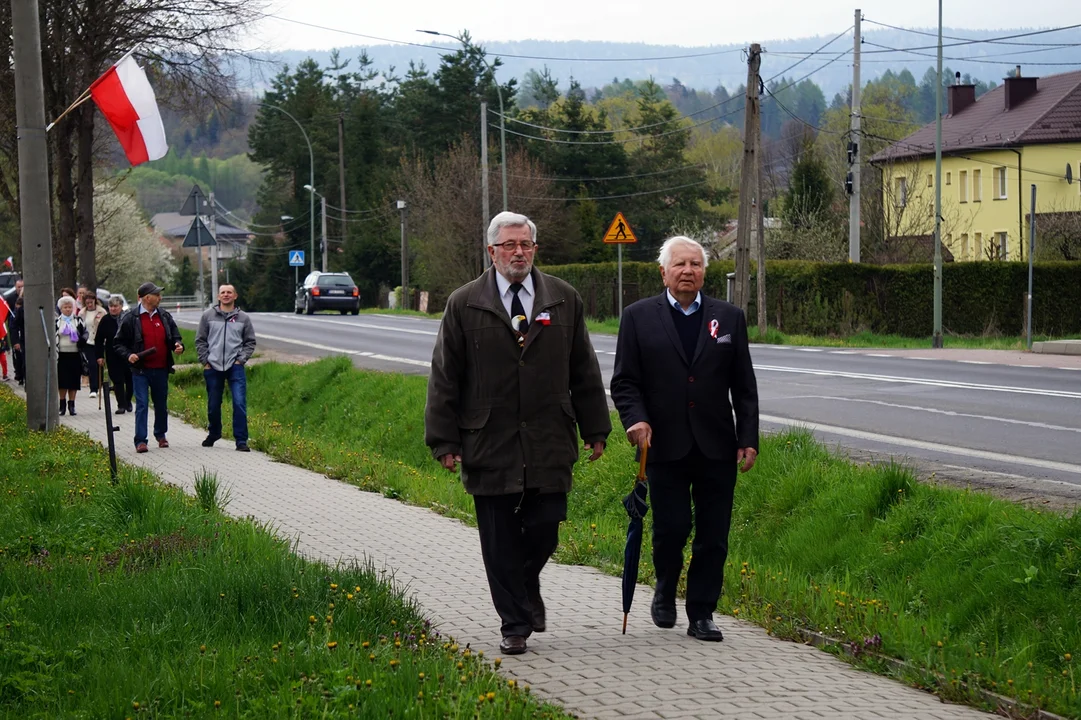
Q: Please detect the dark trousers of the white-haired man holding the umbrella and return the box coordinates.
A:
[646,448,736,621]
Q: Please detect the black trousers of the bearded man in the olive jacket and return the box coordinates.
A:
[473,490,566,638]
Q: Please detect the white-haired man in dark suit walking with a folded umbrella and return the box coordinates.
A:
[612,237,758,641]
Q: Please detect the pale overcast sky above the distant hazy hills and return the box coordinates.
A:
[255,0,1081,50]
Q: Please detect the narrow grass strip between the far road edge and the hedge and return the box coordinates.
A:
[586,318,1081,351]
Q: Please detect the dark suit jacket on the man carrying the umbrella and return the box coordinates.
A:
[612,293,758,463]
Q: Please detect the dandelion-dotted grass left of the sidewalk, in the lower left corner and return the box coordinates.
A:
[0,388,564,720]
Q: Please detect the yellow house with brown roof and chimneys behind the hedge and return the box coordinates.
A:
[871,66,1081,261]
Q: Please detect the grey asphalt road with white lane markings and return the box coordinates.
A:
[176,312,1081,492]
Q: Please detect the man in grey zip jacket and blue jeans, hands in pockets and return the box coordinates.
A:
[196,285,255,453]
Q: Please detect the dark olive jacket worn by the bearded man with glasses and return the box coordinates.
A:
[424,268,612,495]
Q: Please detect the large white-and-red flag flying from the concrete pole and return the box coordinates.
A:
[90,55,169,165]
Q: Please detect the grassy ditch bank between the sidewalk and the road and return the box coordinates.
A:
[171,358,1081,715]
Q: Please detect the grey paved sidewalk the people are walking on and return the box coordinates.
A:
[54,404,989,720]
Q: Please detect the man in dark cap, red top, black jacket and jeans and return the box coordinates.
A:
[112,282,184,453]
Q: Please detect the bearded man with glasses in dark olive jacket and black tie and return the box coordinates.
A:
[424,212,612,655]
